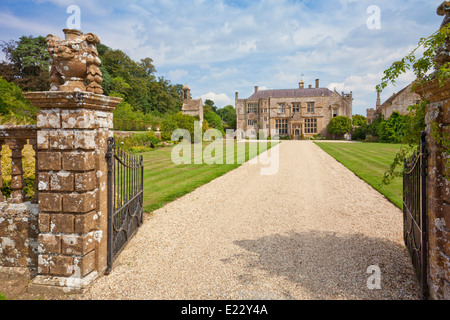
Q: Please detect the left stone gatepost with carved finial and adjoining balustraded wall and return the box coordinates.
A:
[0,29,121,292]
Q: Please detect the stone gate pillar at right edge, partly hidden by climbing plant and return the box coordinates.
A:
[416,1,450,300]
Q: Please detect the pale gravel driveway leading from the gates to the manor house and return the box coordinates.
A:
[80,141,420,300]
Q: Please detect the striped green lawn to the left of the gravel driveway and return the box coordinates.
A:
[143,142,277,212]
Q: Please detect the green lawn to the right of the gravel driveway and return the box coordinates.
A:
[316,142,403,209]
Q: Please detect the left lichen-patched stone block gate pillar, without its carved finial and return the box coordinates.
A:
[22,91,120,292]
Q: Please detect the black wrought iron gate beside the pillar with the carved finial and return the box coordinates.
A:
[106,138,144,274]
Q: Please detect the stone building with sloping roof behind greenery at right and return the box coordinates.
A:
[367,83,420,124]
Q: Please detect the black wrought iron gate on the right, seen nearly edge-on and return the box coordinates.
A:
[403,133,428,299]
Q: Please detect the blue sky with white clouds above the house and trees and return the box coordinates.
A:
[0,0,442,115]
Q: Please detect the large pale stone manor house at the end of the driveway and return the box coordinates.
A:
[235,79,353,140]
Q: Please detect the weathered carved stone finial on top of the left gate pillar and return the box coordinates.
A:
[47,29,103,94]
